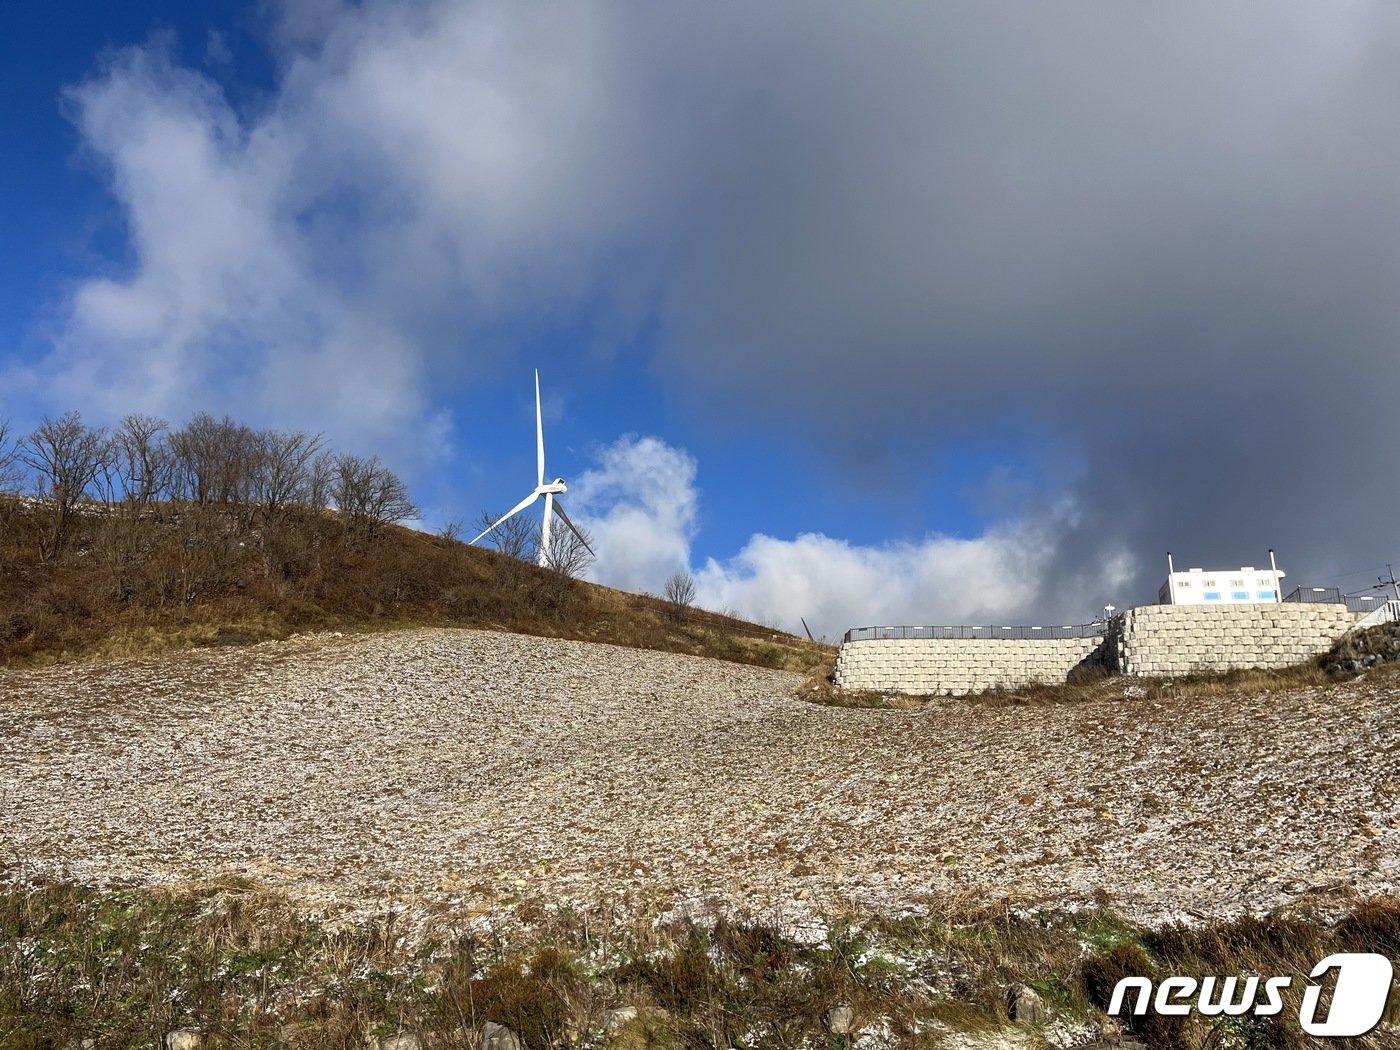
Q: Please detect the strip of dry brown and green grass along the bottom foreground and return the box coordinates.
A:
[0,883,1400,1050]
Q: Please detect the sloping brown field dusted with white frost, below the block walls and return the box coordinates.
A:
[0,630,1400,921]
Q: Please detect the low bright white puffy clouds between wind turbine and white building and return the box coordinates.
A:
[570,437,1134,640]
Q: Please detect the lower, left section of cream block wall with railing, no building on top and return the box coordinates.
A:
[836,638,1103,696]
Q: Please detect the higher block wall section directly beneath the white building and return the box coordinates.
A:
[1105,602,1355,676]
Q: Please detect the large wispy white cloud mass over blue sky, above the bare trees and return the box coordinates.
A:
[17,3,644,463]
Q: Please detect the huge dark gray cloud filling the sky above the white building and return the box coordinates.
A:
[616,4,1400,604]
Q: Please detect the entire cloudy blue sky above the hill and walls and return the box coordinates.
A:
[0,0,1400,636]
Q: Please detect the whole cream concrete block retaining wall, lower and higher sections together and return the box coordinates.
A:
[836,602,1355,696]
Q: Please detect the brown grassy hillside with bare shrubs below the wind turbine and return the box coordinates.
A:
[0,497,830,673]
